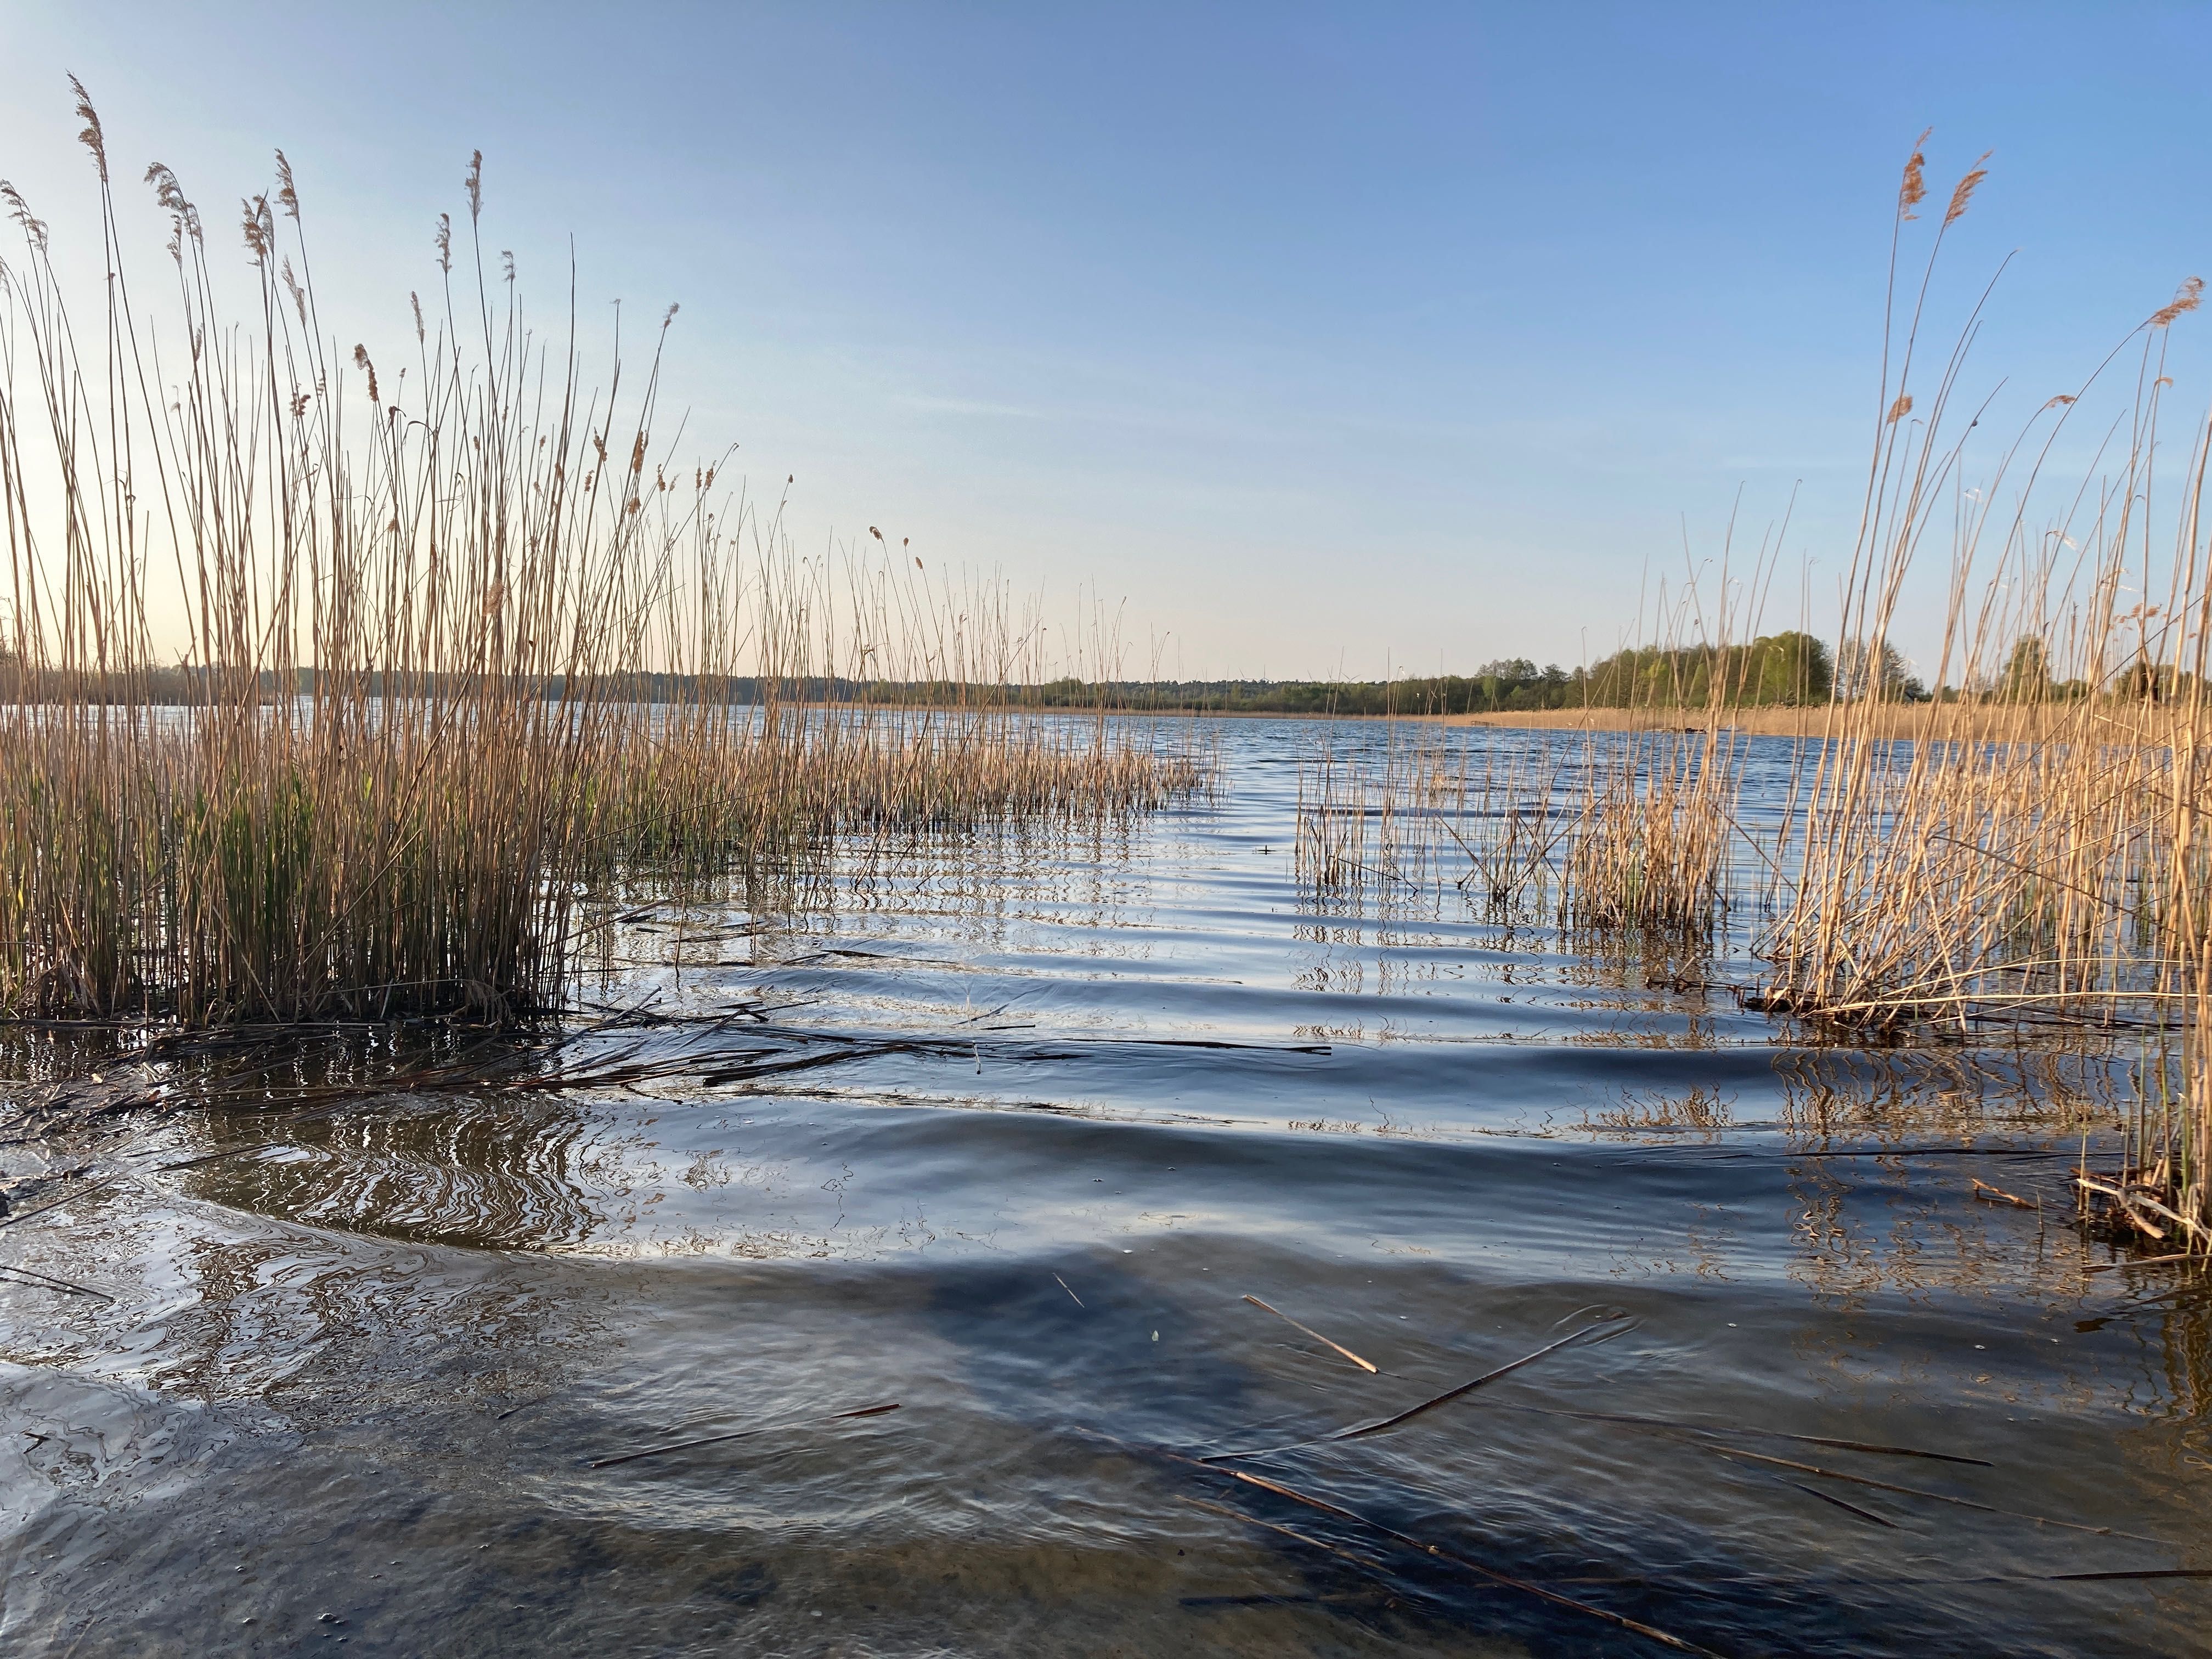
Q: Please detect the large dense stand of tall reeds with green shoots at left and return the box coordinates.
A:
[0,86,1203,1024]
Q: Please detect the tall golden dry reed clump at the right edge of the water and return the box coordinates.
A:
[1768,140,2212,1243]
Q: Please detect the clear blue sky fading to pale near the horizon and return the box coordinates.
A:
[0,0,2212,679]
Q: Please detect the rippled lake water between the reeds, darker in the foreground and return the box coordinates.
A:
[0,721,2212,1655]
